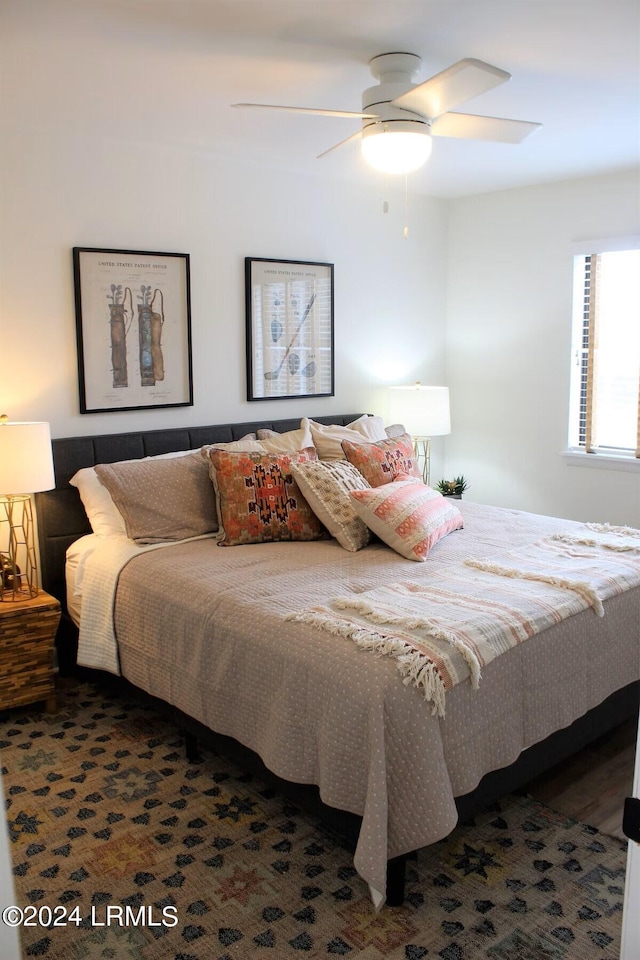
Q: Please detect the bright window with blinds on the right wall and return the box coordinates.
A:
[569,238,640,458]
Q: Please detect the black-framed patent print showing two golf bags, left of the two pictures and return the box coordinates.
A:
[73,247,193,413]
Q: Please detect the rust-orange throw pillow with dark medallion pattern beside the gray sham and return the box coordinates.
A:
[209,447,327,547]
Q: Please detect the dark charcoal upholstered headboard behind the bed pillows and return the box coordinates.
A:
[36,413,361,610]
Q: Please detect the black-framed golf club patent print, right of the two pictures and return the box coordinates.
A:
[245,257,335,400]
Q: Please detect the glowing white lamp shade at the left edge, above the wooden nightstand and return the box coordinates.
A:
[0,422,55,496]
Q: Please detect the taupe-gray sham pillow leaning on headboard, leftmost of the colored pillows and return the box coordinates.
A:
[95,452,218,543]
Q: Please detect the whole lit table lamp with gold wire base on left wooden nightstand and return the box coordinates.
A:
[0,414,55,601]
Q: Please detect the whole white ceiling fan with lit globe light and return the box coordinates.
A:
[232,53,542,173]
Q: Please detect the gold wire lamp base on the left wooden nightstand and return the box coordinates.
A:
[0,494,38,603]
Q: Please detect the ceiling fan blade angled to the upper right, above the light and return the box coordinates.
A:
[392,57,511,119]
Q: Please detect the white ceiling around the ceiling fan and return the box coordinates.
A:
[5,0,640,197]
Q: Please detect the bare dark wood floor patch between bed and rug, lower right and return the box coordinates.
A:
[525,720,638,840]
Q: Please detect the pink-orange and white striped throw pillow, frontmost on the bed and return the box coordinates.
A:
[349,474,463,560]
